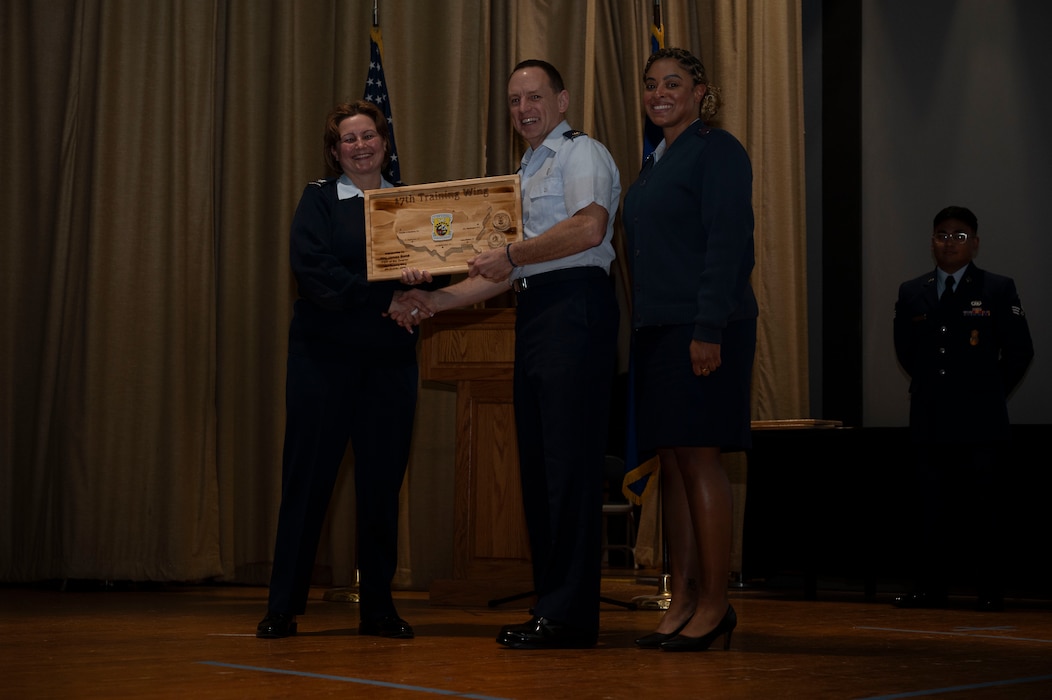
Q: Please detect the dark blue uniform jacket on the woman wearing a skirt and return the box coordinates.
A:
[623,122,757,343]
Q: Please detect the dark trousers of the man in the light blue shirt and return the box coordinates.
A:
[514,267,619,634]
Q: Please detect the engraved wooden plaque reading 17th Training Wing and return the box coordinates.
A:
[365,175,523,280]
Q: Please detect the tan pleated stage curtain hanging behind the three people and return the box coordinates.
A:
[0,0,808,587]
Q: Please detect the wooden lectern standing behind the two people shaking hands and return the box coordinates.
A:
[421,308,533,605]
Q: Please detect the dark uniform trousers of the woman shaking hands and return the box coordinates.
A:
[268,347,419,620]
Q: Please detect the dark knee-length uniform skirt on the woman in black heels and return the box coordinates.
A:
[632,319,756,452]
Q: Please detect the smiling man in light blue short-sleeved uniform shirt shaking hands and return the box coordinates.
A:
[392,60,621,648]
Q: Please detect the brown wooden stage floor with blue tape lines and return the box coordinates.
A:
[0,576,1052,700]
